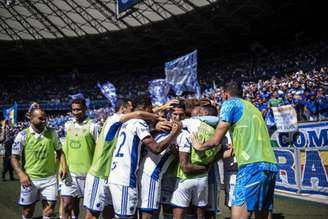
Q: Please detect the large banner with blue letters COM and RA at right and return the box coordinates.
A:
[271,121,328,198]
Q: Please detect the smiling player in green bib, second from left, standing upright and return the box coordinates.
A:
[61,99,99,219]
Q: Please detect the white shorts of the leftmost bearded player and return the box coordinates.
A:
[18,176,57,205]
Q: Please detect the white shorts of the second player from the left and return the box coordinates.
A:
[60,174,86,198]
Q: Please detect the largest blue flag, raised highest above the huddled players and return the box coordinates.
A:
[165,50,200,96]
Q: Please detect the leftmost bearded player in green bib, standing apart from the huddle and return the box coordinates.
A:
[11,108,67,219]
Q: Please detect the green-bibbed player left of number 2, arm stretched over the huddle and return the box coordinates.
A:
[83,99,163,219]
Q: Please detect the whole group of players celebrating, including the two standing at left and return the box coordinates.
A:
[12,82,277,219]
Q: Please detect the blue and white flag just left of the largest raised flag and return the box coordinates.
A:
[148,79,170,106]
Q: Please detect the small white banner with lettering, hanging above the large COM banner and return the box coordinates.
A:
[272,105,297,132]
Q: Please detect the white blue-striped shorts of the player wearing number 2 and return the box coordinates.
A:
[108,183,138,218]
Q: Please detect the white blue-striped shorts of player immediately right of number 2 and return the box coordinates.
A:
[138,173,161,212]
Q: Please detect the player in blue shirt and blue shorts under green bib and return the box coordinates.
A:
[193,82,278,219]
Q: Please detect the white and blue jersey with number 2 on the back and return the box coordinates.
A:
[108,119,150,187]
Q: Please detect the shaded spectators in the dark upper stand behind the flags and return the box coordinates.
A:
[0,41,328,105]
